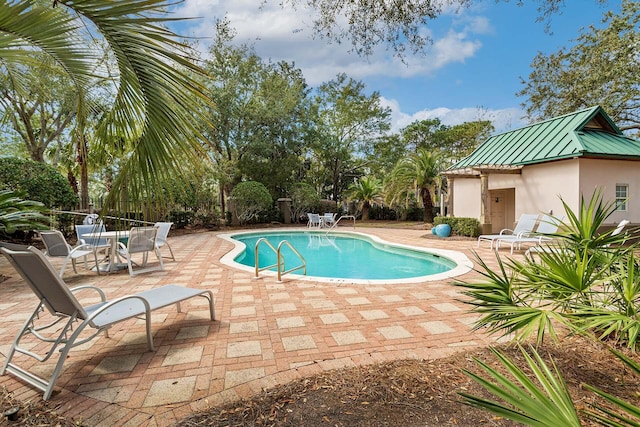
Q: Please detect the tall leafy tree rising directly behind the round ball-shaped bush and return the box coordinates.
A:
[200,20,308,210]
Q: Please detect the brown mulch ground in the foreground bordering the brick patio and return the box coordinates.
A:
[0,337,640,427]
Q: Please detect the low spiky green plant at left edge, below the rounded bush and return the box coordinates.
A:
[0,190,49,234]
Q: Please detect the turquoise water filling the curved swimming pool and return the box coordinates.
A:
[231,231,457,280]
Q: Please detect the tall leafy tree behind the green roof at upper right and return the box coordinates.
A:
[518,0,640,133]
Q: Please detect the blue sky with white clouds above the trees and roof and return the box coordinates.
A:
[173,0,621,133]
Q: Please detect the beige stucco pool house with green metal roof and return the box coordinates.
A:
[444,106,640,233]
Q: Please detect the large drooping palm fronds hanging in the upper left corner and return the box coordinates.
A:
[0,0,206,211]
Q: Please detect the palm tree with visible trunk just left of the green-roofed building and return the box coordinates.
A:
[386,148,441,223]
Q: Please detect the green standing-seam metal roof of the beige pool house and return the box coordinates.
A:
[447,106,640,172]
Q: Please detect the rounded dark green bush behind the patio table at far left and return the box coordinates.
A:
[0,158,78,209]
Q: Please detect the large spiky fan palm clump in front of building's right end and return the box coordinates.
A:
[457,190,640,348]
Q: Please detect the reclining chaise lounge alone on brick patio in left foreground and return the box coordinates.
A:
[0,247,215,400]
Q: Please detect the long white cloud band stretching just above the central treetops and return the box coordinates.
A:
[169,0,488,86]
